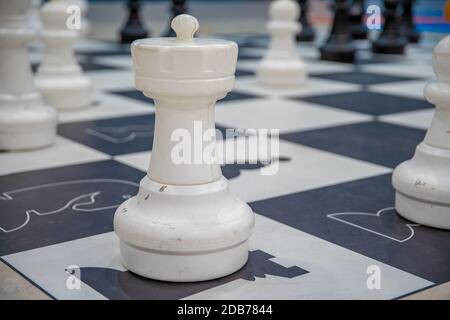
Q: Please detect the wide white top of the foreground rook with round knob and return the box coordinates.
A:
[131,14,238,96]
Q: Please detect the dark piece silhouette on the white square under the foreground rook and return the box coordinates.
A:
[80,250,308,300]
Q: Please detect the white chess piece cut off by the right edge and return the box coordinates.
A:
[392,36,450,229]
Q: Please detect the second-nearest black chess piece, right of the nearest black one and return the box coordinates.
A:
[372,0,407,54]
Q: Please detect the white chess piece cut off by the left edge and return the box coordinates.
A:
[0,0,57,150]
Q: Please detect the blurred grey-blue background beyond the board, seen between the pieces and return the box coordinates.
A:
[72,0,450,40]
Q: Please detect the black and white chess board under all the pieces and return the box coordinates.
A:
[0,35,450,299]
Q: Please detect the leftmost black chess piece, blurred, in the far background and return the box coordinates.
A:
[120,0,150,43]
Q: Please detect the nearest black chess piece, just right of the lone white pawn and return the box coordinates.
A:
[320,0,356,62]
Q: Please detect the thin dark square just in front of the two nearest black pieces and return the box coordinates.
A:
[313,71,422,85]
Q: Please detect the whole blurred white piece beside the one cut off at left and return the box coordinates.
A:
[35,0,92,109]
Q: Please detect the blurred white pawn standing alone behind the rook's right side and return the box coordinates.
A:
[256,0,308,88]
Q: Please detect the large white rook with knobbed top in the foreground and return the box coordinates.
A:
[114,15,254,281]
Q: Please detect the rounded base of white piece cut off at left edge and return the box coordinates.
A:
[0,93,58,151]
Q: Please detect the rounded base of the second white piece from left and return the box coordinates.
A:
[35,73,92,110]
